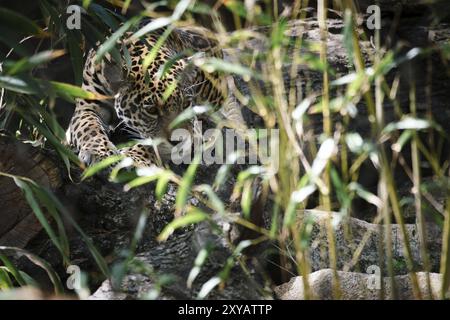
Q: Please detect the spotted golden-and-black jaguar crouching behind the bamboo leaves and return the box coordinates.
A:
[68,25,232,165]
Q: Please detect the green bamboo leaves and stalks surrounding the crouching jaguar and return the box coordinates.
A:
[0,0,450,298]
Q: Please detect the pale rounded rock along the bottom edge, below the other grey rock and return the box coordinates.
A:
[275,269,442,300]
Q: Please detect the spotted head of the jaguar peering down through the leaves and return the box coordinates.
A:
[115,57,199,160]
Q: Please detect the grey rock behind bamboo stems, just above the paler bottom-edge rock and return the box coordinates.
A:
[304,210,442,274]
